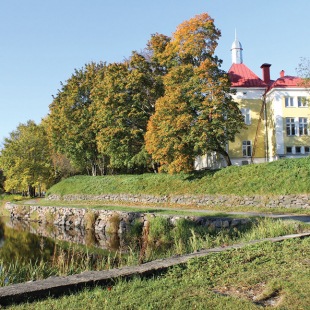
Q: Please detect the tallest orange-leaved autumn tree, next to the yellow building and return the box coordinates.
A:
[145,13,244,173]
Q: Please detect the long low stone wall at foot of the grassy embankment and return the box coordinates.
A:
[47,194,310,209]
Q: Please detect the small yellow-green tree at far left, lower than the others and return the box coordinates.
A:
[0,121,52,197]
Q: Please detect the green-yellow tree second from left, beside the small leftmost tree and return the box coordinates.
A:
[46,63,105,175]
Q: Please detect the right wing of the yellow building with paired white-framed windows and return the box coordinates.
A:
[266,70,310,160]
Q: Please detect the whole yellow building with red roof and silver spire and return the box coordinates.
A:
[195,38,310,169]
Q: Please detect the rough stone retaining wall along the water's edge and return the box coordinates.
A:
[6,203,250,234]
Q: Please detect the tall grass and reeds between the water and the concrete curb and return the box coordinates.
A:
[0,217,306,286]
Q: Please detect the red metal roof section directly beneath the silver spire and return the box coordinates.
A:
[228,64,267,88]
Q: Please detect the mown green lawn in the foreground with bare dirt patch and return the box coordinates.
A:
[9,238,310,310]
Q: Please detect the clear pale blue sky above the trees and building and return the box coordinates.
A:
[0,0,310,144]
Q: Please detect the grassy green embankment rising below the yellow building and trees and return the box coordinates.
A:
[48,157,310,195]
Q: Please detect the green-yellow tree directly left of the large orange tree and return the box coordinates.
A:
[92,52,163,171]
